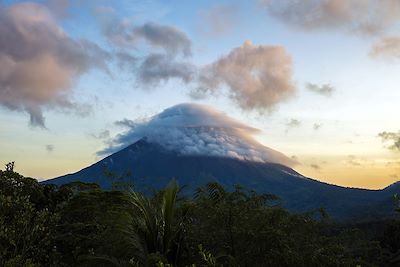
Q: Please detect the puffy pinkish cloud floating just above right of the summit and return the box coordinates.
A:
[192,41,295,110]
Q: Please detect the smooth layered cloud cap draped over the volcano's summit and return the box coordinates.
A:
[99,104,295,166]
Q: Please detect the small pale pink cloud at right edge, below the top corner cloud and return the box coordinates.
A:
[369,37,400,60]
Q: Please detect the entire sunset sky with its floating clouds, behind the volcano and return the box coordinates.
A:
[0,0,400,189]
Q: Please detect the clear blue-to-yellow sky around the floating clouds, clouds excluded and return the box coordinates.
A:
[0,0,400,188]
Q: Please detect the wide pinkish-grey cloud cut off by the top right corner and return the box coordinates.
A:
[262,0,400,35]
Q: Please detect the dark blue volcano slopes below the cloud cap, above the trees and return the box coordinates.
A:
[45,140,400,219]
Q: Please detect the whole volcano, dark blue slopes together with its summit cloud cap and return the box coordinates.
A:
[44,104,400,219]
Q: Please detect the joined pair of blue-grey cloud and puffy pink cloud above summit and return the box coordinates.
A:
[99,10,295,110]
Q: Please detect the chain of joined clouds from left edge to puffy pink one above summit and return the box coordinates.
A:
[0,0,295,127]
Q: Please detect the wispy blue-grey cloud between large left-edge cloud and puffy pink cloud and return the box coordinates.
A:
[97,7,195,88]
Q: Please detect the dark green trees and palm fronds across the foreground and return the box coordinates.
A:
[0,163,400,267]
